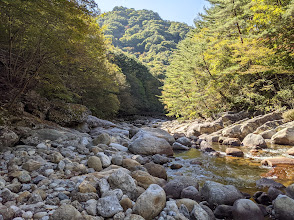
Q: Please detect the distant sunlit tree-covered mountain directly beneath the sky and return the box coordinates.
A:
[98,7,191,79]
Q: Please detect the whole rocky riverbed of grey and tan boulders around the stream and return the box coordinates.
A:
[0,113,294,220]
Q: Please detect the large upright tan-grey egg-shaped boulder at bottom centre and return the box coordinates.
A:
[133,184,166,220]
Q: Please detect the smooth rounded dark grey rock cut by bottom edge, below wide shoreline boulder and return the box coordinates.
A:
[233,199,264,220]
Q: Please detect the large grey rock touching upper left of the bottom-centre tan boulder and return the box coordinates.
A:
[108,169,137,199]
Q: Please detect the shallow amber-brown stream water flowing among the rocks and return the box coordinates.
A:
[168,144,294,195]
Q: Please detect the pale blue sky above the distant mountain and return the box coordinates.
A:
[96,0,208,25]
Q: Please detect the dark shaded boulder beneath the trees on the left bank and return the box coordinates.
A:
[48,103,91,126]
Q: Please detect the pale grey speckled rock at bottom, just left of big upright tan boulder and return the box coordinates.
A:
[97,195,123,218]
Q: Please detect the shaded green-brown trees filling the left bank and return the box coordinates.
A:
[0,0,122,117]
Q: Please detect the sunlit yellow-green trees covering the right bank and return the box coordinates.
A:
[162,0,294,118]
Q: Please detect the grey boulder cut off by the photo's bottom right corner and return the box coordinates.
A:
[273,195,294,220]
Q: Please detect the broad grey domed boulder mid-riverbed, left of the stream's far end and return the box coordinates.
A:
[129,131,173,156]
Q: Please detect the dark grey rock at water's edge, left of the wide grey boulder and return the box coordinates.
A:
[163,177,199,199]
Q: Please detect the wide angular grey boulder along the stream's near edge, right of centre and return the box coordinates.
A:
[200,181,243,205]
